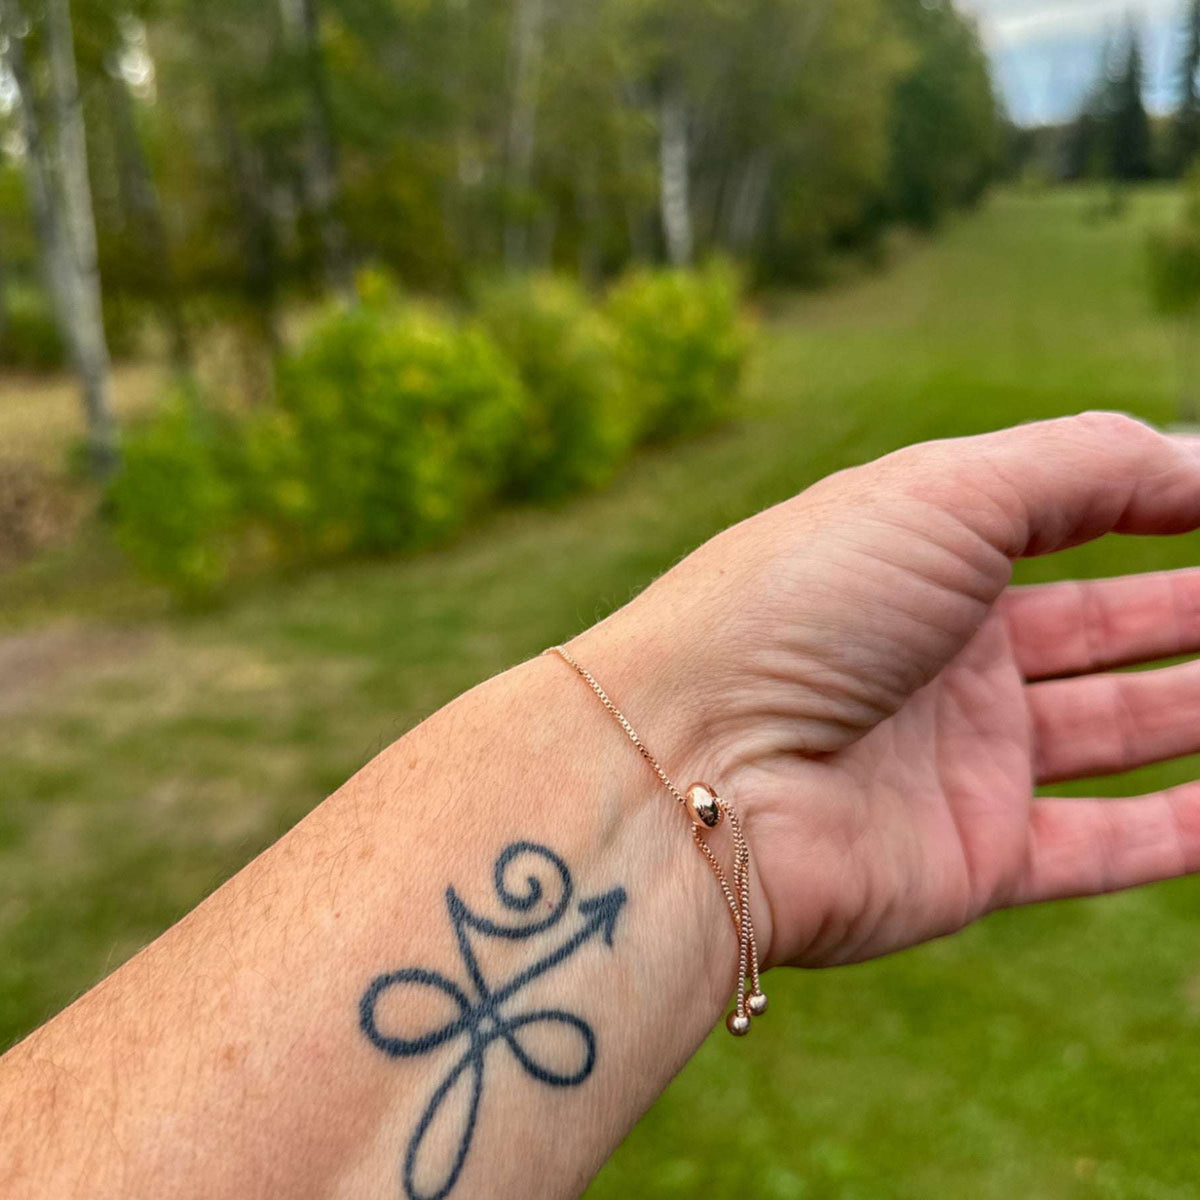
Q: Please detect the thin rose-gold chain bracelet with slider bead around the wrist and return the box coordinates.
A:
[545,646,767,1038]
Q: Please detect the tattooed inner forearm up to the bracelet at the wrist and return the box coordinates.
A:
[0,659,733,1198]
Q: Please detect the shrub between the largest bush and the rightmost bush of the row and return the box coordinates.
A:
[479,276,634,499]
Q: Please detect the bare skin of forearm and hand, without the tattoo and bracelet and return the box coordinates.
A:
[0,414,1200,1200]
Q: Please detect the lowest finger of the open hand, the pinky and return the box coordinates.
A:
[1012,782,1200,905]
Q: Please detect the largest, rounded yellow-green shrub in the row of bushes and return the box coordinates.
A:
[280,298,526,554]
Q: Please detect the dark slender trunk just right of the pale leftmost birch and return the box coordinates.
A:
[107,71,192,373]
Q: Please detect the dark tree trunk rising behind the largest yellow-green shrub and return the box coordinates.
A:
[281,0,354,294]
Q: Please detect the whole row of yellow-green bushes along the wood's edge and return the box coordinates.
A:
[112,264,749,596]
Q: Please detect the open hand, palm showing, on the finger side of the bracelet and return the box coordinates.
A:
[577,414,1200,966]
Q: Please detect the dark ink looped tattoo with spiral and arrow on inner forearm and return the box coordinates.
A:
[359,841,628,1200]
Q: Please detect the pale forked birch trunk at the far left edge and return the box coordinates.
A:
[0,0,119,476]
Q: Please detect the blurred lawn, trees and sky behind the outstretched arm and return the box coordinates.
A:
[0,0,1200,1200]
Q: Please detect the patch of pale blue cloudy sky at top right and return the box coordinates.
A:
[958,0,1184,124]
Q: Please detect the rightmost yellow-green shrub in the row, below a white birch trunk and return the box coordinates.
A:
[607,263,749,442]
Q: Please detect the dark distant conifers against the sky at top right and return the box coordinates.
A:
[1014,0,1200,184]
